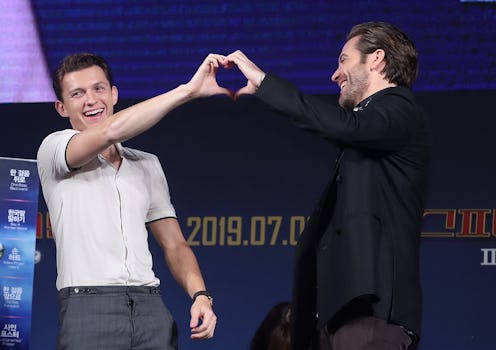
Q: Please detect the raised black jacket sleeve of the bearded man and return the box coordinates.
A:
[255,73,422,151]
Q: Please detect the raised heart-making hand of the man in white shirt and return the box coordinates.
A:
[186,53,233,97]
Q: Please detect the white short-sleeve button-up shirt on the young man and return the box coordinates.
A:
[37,129,176,290]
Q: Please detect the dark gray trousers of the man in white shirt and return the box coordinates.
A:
[57,286,177,350]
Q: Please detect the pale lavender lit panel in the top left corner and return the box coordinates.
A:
[0,0,55,103]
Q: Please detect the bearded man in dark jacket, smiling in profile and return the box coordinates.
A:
[221,22,431,350]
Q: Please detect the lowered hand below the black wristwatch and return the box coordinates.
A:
[189,295,217,339]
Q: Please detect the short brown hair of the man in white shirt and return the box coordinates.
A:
[52,52,114,101]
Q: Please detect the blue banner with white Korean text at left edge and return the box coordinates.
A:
[0,157,39,350]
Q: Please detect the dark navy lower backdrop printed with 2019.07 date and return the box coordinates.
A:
[0,90,496,350]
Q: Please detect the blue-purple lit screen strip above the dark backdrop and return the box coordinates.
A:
[22,0,496,98]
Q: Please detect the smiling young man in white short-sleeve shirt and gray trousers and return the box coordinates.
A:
[37,53,229,350]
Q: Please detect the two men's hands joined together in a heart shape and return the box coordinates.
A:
[188,50,265,99]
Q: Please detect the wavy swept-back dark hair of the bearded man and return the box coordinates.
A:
[347,22,418,88]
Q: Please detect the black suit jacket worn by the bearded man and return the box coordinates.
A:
[256,74,430,350]
